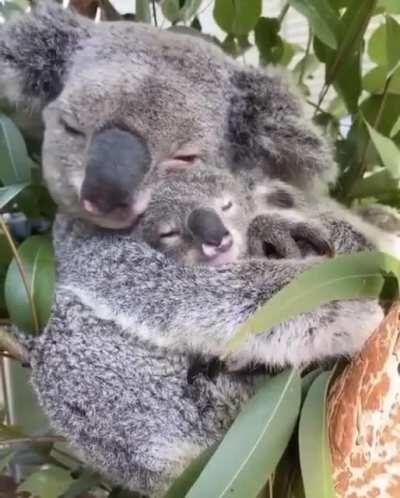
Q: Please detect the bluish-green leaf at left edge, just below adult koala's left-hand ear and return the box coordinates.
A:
[0,114,31,185]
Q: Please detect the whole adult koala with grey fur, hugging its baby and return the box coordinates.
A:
[0,5,382,496]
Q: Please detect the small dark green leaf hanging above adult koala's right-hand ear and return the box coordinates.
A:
[255,17,284,64]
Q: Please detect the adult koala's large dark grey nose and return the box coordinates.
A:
[81,127,151,214]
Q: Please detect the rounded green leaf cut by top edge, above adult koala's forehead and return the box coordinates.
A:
[213,0,261,36]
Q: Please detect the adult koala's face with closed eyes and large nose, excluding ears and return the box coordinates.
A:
[43,28,231,228]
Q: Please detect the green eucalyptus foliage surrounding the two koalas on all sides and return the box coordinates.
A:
[0,0,400,498]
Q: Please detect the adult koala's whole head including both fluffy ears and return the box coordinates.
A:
[0,2,335,228]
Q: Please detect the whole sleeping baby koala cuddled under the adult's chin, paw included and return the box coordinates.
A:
[138,166,333,266]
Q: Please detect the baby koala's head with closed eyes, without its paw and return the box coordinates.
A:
[138,167,253,265]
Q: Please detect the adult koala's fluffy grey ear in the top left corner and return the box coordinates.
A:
[0,2,91,109]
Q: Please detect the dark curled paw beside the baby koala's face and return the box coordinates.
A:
[247,215,335,259]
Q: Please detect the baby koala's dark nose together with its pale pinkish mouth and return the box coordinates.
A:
[187,208,233,258]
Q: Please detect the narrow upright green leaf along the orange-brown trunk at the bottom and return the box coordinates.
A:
[299,372,336,498]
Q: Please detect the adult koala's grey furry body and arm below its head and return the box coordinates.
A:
[21,211,382,496]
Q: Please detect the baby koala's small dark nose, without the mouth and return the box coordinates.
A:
[188,208,229,246]
